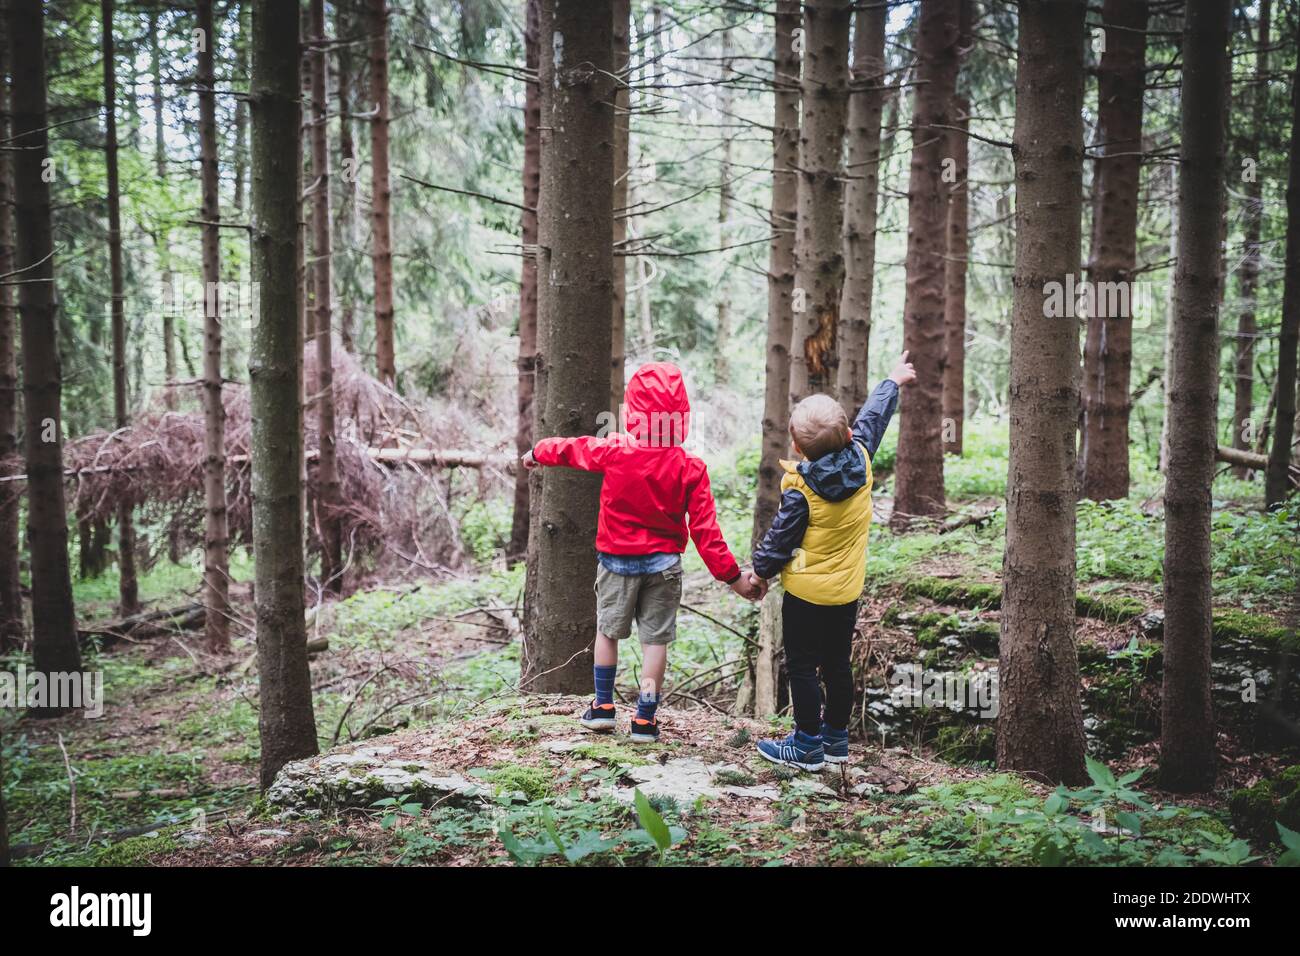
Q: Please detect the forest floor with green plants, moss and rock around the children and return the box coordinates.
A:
[0,426,1300,865]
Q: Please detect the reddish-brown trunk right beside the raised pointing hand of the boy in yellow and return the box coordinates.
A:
[891,0,961,528]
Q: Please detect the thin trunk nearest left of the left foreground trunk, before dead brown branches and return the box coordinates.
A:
[198,0,230,654]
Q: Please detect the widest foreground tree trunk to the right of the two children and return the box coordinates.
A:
[997,0,1087,784]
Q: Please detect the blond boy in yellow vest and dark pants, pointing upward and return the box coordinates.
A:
[749,352,917,770]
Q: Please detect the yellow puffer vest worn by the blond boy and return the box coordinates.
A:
[781,442,871,605]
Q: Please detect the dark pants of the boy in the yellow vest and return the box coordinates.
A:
[781,592,858,735]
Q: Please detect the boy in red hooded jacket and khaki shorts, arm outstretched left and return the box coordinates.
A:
[523,362,759,743]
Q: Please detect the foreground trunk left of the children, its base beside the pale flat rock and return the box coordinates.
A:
[248,3,317,788]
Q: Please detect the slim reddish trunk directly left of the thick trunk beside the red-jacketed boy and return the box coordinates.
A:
[508,0,542,559]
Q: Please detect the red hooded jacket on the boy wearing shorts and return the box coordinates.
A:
[533,362,740,584]
